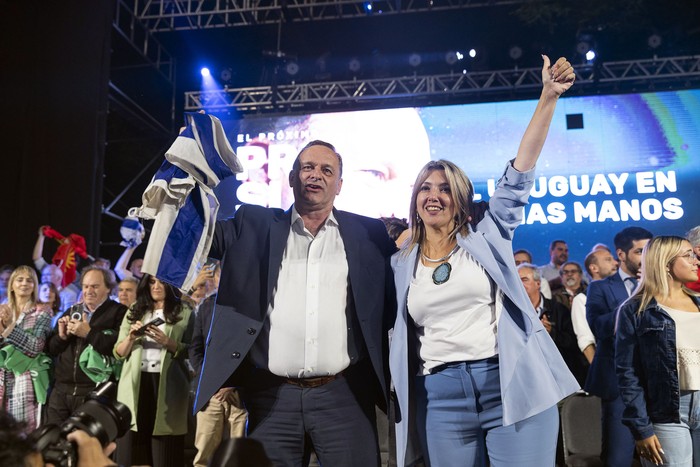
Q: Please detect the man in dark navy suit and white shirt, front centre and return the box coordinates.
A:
[195,141,396,467]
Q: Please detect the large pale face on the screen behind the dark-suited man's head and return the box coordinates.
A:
[237,109,430,217]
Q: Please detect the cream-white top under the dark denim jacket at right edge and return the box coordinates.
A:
[659,305,700,391]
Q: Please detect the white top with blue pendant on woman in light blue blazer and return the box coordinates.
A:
[408,248,500,374]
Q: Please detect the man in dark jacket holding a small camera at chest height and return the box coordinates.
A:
[46,265,126,424]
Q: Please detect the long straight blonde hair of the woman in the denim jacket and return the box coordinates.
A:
[628,235,698,313]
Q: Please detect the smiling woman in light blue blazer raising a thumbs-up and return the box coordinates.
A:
[390,56,578,467]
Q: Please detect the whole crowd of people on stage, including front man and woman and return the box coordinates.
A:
[0,56,700,467]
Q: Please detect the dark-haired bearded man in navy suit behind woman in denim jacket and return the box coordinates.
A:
[585,227,652,467]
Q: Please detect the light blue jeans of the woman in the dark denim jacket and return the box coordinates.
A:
[642,391,700,467]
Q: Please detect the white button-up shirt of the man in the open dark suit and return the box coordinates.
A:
[251,208,350,378]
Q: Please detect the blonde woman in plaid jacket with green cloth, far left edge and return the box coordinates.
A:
[0,266,51,429]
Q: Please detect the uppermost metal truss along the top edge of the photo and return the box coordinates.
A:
[129,0,525,32]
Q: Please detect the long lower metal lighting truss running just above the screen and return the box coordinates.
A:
[185,56,700,113]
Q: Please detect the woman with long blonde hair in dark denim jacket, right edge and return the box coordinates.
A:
[615,236,700,466]
